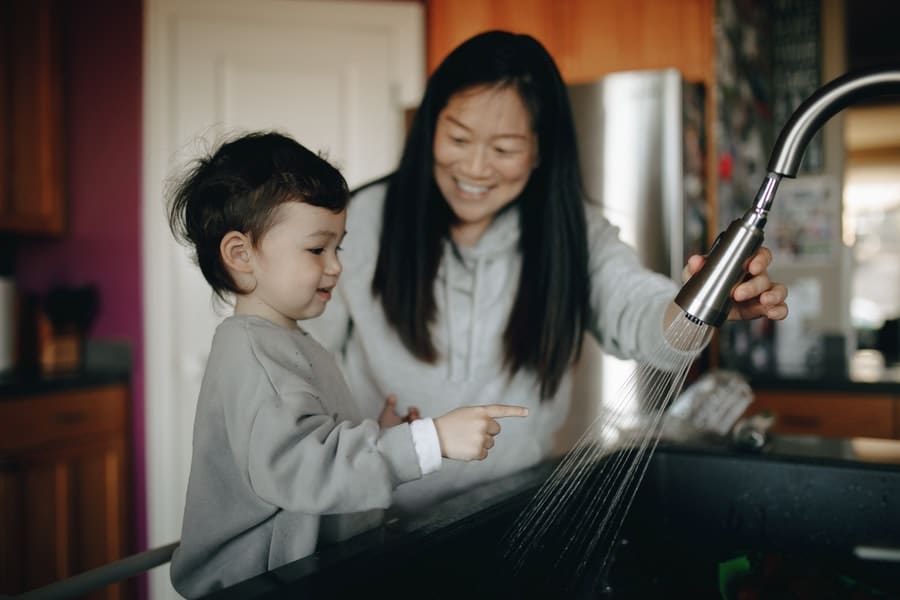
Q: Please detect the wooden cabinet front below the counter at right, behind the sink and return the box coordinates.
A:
[746,390,900,438]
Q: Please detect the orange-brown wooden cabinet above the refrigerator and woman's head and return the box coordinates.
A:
[427,0,714,83]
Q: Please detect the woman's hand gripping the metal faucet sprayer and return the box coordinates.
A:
[682,246,788,321]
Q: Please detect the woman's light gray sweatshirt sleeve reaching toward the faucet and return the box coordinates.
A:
[587,206,678,367]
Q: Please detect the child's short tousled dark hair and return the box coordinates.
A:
[168,132,350,298]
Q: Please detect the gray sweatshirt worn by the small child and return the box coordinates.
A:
[171,316,421,597]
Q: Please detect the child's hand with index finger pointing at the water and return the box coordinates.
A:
[434,404,528,460]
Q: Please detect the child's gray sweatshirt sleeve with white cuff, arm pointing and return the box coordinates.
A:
[248,389,421,514]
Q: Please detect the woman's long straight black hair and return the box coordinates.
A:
[372,31,590,398]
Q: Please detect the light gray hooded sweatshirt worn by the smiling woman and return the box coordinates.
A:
[304,180,678,512]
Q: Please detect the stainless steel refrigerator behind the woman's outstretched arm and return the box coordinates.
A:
[556,69,707,453]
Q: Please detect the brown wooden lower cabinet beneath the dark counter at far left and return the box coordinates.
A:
[0,385,131,599]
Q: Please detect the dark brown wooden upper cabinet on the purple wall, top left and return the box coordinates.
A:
[0,0,66,235]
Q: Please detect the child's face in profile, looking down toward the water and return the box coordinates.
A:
[236,202,347,328]
